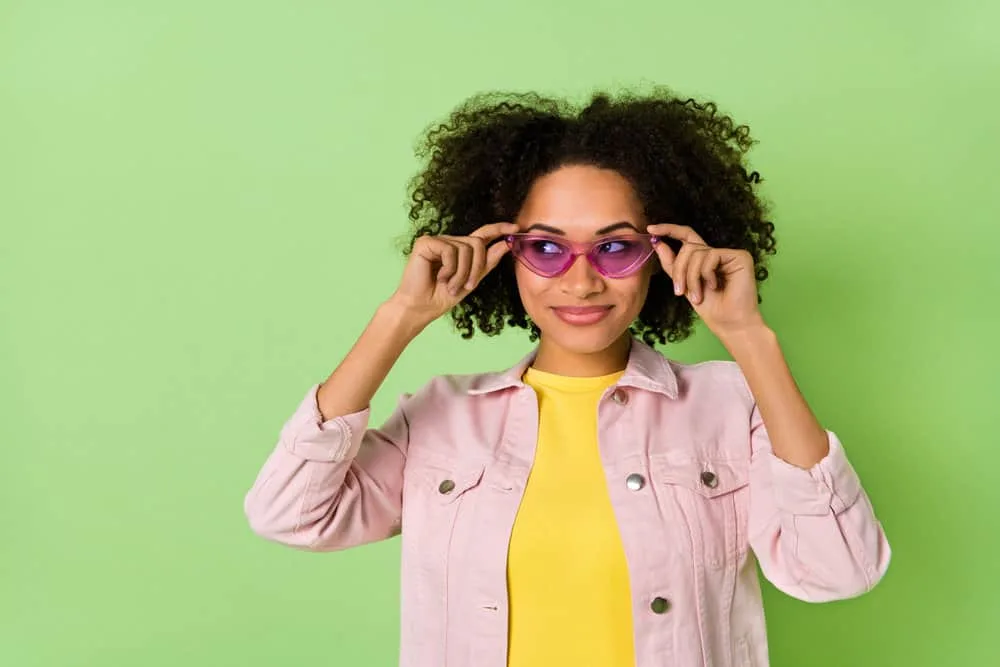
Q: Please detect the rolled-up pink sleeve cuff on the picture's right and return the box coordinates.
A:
[768,431,861,516]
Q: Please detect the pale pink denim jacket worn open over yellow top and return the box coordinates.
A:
[245,340,890,667]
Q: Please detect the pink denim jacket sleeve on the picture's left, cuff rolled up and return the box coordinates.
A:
[244,384,409,551]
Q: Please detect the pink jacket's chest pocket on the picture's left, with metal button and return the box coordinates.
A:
[403,460,485,567]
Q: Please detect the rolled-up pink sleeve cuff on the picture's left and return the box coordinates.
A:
[281,384,371,463]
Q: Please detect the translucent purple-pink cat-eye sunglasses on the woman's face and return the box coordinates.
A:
[506,234,661,278]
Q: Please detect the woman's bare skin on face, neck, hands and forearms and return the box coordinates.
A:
[317,166,829,468]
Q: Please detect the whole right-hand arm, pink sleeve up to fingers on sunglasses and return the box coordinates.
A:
[646,223,890,602]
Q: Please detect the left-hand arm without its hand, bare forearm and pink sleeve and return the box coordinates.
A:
[244,303,422,551]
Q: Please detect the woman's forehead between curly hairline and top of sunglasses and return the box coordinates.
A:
[517,166,642,233]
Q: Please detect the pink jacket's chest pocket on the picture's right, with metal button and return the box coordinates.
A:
[654,457,750,568]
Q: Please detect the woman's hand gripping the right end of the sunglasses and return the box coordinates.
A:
[646,224,763,336]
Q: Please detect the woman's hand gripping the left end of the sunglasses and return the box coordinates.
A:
[390,222,518,323]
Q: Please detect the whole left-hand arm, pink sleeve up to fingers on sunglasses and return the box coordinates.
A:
[244,223,517,550]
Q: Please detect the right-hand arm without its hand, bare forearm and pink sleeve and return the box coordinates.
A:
[723,325,891,602]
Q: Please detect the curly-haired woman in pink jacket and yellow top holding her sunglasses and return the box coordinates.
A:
[246,91,889,667]
